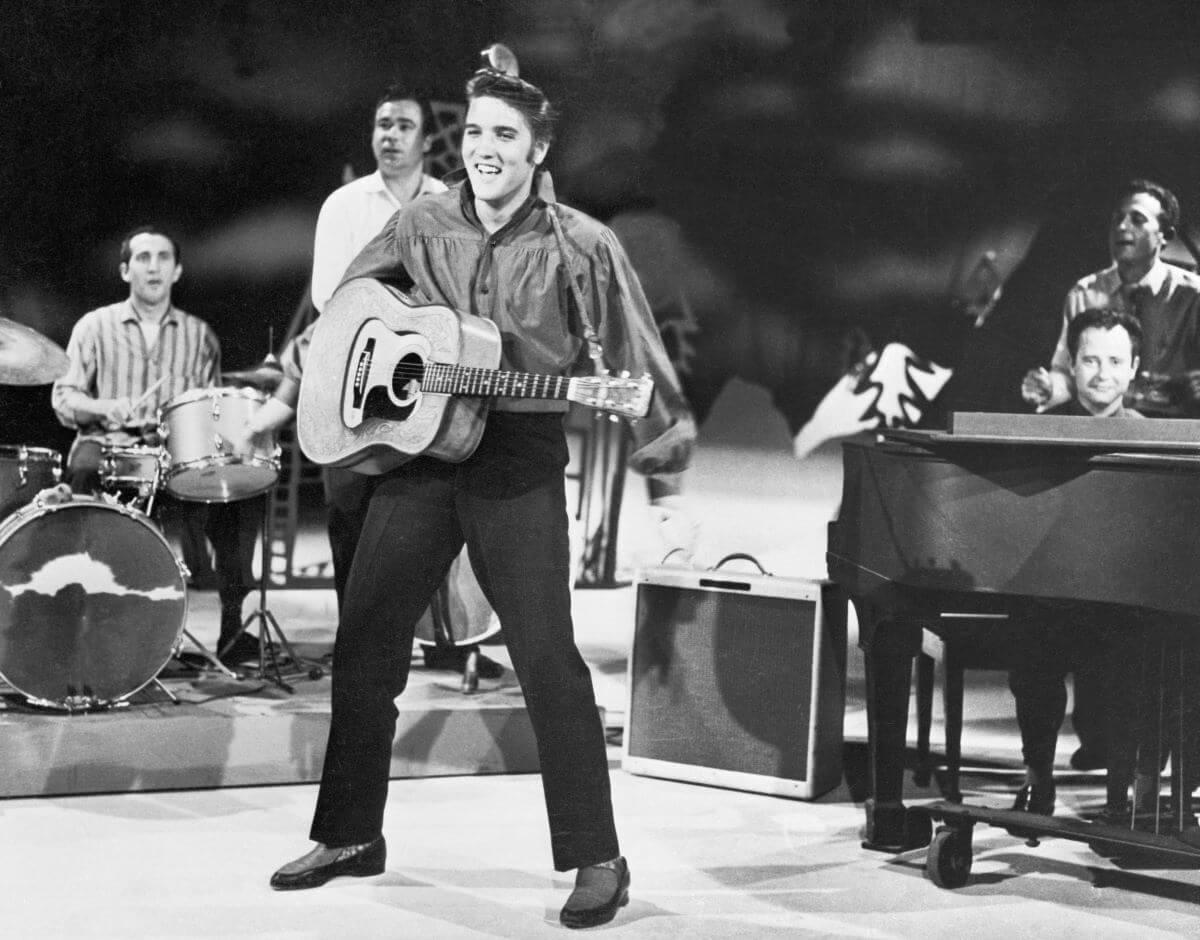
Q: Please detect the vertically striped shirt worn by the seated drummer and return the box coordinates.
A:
[50,299,221,443]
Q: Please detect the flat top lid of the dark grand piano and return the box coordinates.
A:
[881,412,1200,453]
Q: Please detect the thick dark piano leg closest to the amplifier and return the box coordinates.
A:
[854,600,931,852]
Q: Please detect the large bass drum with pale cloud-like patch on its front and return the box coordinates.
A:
[0,497,187,711]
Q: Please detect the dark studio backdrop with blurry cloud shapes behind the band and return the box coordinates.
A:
[0,0,1200,443]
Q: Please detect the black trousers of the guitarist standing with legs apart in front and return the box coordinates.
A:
[311,412,619,872]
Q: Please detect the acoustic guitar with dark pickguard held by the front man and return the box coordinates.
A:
[296,277,654,473]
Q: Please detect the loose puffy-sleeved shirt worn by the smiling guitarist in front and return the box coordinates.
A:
[346,182,696,477]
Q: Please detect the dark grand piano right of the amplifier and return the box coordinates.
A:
[827,413,1200,861]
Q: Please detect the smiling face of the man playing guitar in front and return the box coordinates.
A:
[462,97,550,220]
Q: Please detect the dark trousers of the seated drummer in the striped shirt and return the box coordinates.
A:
[66,441,255,649]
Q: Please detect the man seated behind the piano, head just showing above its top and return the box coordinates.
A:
[1008,309,1142,815]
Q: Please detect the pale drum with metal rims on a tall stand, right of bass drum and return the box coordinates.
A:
[158,388,280,503]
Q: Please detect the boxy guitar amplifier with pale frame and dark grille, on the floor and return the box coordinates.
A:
[622,568,847,800]
